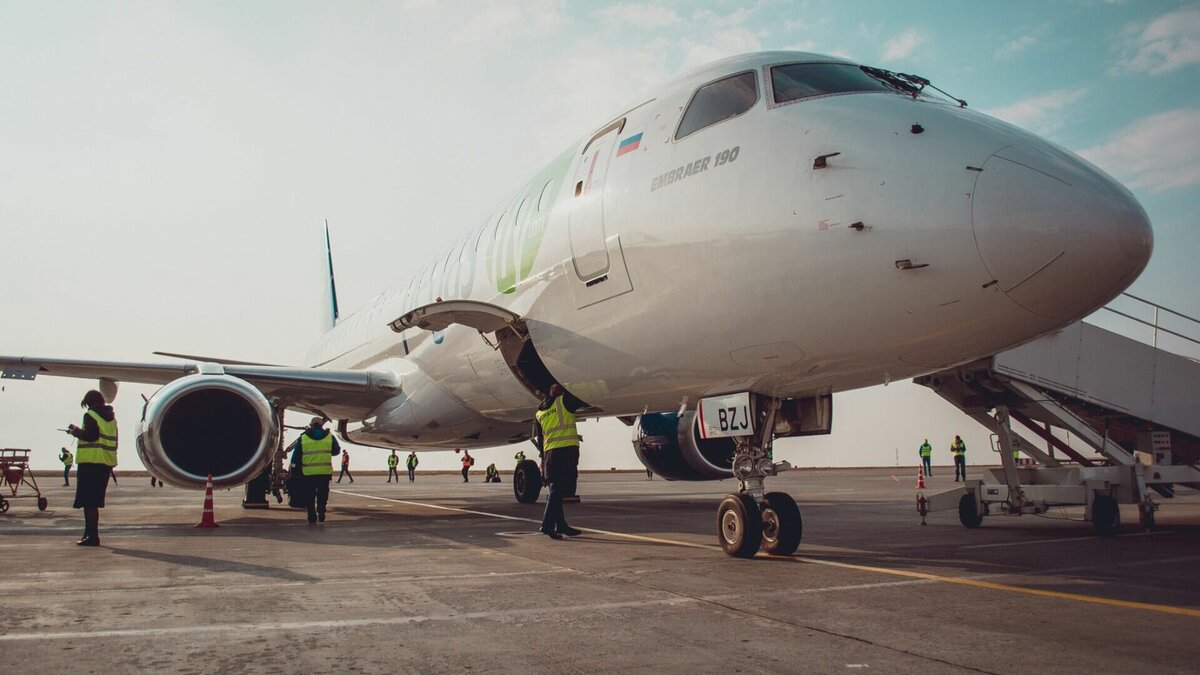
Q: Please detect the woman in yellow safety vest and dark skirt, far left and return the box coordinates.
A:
[67,389,116,546]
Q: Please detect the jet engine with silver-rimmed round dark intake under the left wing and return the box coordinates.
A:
[138,375,280,488]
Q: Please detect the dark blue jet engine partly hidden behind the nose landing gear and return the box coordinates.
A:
[634,412,736,480]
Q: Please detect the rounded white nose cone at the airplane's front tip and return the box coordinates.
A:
[972,144,1153,321]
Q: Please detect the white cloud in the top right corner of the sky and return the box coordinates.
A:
[1111,6,1200,74]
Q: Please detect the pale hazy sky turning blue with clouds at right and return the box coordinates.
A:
[0,0,1200,470]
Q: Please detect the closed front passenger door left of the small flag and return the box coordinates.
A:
[566,119,625,281]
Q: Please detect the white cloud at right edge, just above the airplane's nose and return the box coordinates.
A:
[1079,108,1200,192]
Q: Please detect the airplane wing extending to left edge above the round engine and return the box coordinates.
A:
[0,356,401,418]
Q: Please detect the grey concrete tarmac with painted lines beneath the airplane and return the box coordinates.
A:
[0,467,1200,674]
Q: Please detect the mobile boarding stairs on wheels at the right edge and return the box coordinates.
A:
[914,298,1200,536]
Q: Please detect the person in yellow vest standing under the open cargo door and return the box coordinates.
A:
[533,383,583,539]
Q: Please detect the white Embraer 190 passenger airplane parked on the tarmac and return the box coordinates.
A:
[0,52,1153,557]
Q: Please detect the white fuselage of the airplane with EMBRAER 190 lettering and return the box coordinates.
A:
[295,53,1151,446]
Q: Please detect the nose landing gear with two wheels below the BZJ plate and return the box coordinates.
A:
[716,396,804,557]
